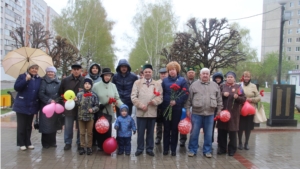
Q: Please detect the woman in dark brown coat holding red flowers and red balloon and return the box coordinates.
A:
[217,71,246,156]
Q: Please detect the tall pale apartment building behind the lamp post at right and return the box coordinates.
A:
[261,0,300,70]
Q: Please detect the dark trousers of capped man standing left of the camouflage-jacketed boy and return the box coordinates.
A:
[64,116,80,144]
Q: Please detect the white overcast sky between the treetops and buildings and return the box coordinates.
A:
[45,0,272,62]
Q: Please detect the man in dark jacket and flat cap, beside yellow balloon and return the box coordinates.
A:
[59,64,84,150]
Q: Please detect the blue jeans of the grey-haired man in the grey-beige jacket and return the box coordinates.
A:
[188,114,214,154]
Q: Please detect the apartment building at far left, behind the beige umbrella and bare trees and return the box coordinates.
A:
[0,0,58,80]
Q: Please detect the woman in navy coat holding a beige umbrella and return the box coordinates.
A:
[13,64,41,151]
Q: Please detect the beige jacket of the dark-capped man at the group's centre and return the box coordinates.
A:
[131,78,163,117]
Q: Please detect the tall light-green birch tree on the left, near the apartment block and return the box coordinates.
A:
[53,0,116,68]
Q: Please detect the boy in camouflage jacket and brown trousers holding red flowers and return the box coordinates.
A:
[74,78,99,155]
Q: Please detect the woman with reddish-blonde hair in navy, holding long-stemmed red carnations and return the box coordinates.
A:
[161,61,188,156]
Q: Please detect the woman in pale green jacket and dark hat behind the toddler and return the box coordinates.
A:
[92,68,123,151]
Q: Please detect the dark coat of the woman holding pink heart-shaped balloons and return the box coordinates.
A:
[39,76,60,134]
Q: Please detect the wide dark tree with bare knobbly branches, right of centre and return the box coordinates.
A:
[161,18,246,73]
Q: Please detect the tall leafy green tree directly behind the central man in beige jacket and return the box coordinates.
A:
[129,0,176,73]
